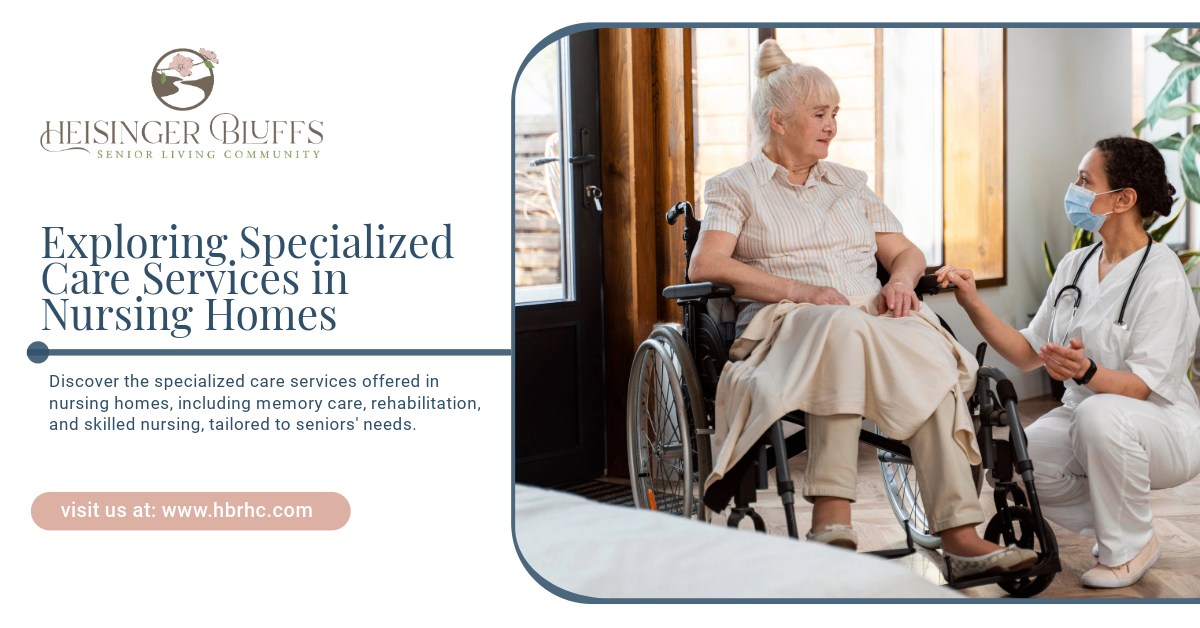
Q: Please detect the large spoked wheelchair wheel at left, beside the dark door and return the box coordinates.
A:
[625,339,700,516]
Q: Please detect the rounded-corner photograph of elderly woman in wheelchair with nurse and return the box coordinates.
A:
[508,23,1200,603]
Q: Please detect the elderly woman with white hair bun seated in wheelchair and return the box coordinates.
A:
[689,40,1036,575]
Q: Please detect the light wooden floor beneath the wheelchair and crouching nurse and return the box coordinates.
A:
[686,397,1200,598]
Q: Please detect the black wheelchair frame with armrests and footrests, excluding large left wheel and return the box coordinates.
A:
[628,202,1062,597]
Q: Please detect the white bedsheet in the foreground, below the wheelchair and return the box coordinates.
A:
[516,484,958,598]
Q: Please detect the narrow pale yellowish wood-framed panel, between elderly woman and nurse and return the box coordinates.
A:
[943,29,1007,285]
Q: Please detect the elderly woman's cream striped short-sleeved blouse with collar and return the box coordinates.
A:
[701,152,904,331]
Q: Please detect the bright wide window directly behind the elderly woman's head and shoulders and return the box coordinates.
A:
[692,29,943,267]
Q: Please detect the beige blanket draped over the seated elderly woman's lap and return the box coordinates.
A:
[704,294,980,486]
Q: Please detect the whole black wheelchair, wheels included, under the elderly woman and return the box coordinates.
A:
[626,202,1062,597]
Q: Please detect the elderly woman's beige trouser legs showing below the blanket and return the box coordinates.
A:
[803,394,984,534]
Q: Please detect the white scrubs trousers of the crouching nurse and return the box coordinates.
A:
[1025,395,1200,567]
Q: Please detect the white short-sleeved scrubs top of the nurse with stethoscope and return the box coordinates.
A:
[1021,243,1200,413]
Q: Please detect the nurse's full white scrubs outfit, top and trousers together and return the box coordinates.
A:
[1021,244,1200,567]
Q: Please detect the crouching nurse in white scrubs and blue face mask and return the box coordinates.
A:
[937,137,1200,588]
